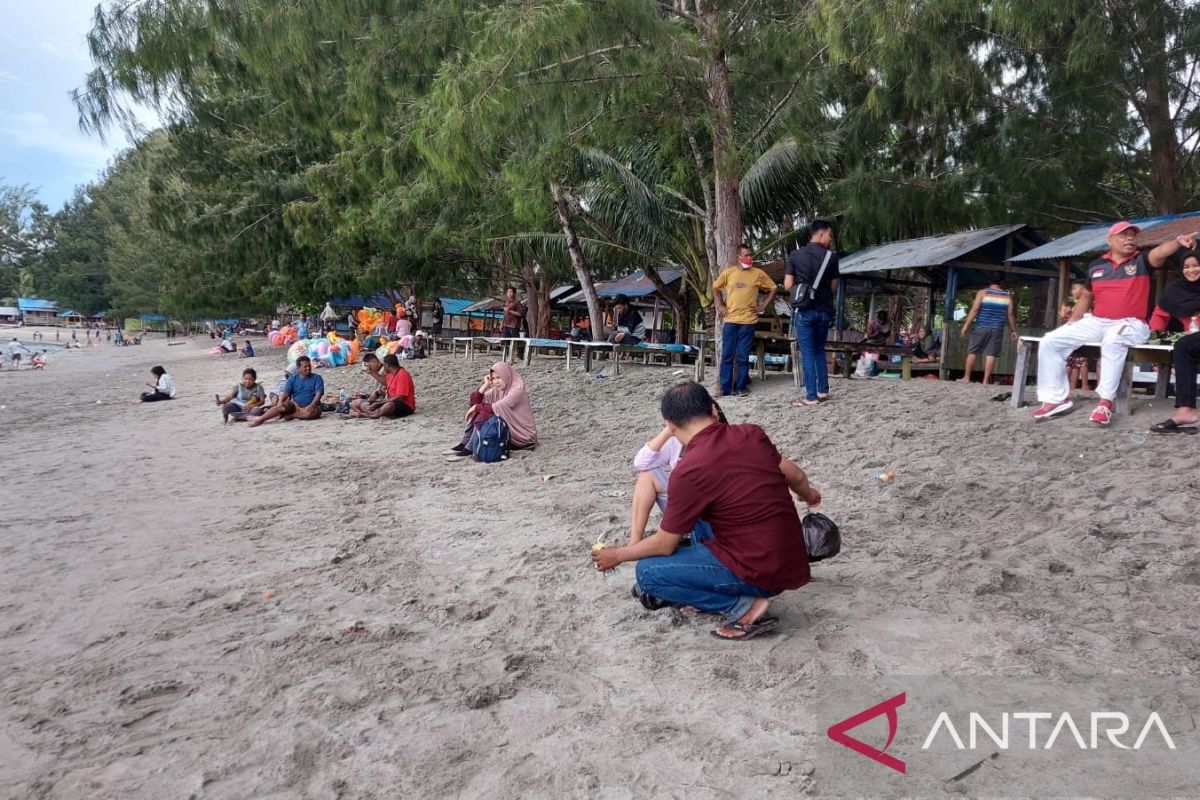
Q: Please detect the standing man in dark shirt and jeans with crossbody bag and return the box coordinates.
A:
[784,219,839,407]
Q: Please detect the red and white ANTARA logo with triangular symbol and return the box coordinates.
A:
[828,692,1176,775]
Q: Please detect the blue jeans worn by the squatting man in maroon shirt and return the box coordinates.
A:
[637,539,779,622]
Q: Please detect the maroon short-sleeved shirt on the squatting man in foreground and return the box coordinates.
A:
[660,422,809,591]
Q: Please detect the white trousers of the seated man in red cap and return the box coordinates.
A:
[1038,314,1150,403]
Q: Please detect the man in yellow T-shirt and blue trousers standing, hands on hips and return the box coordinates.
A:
[713,245,775,397]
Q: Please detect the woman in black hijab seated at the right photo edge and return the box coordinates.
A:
[1150,252,1200,433]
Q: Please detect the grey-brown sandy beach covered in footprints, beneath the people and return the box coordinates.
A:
[0,333,1200,799]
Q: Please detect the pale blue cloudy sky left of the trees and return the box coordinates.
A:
[0,0,154,209]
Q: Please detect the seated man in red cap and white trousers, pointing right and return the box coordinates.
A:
[1033,222,1195,426]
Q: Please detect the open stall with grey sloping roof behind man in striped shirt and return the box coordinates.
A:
[830,223,1060,380]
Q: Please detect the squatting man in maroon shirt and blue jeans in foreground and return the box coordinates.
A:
[592,383,821,639]
